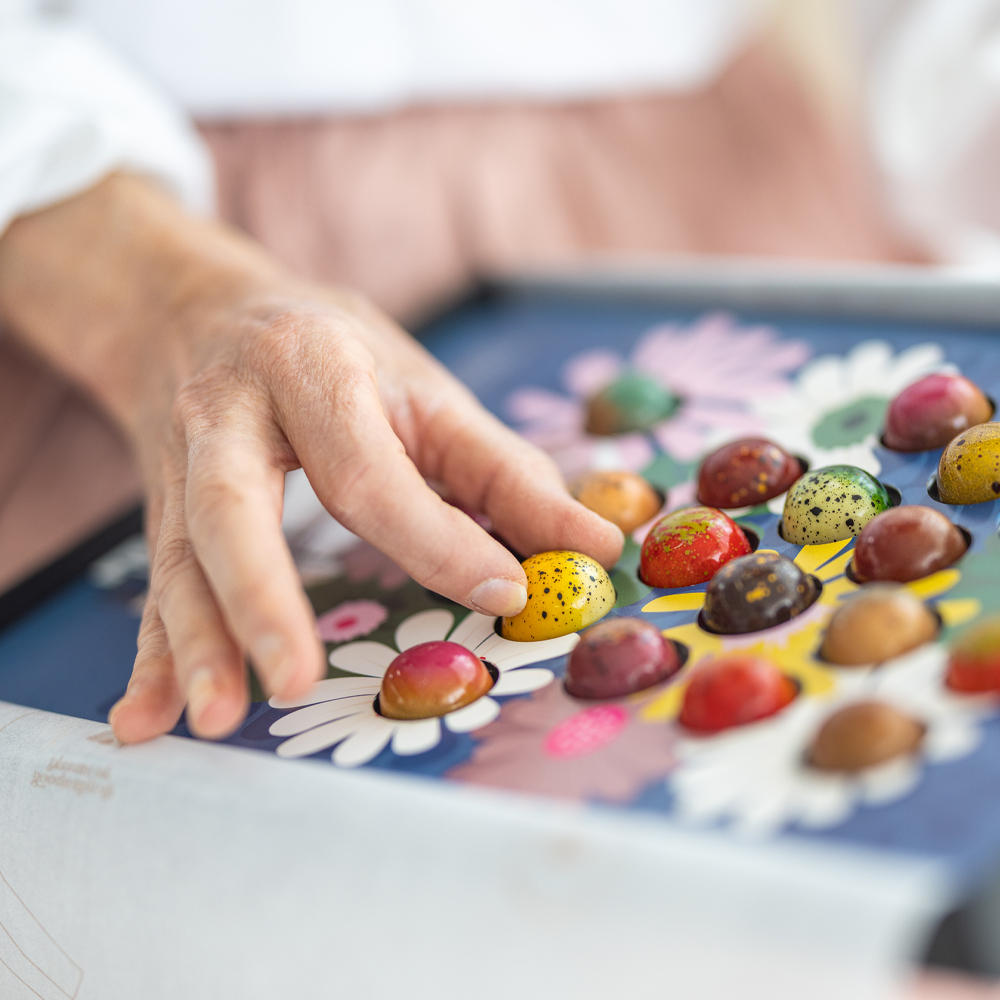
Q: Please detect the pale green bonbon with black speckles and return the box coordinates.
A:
[781,465,889,545]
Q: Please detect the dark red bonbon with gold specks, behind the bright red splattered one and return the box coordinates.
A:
[698,438,802,509]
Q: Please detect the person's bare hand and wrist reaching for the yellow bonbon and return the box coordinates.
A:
[0,178,623,742]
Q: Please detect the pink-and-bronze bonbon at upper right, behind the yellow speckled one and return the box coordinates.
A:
[882,375,993,451]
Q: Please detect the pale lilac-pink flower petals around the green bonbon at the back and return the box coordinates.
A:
[507,313,809,482]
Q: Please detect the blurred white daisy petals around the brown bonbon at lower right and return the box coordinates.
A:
[668,644,998,836]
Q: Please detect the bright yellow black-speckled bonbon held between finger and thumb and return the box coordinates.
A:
[501,552,616,642]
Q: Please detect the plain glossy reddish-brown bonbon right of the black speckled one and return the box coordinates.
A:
[851,504,966,583]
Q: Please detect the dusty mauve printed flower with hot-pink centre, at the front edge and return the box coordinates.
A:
[448,684,676,802]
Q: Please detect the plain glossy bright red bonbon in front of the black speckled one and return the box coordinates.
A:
[680,654,798,733]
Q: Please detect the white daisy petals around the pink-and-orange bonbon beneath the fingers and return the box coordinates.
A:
[269,608,579,767]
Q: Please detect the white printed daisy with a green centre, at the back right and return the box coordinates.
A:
[750,340,956,492]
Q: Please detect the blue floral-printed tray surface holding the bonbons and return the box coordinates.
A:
[0,282,1000,984]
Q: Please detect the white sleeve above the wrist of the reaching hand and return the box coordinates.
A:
[0,14,213,234]
